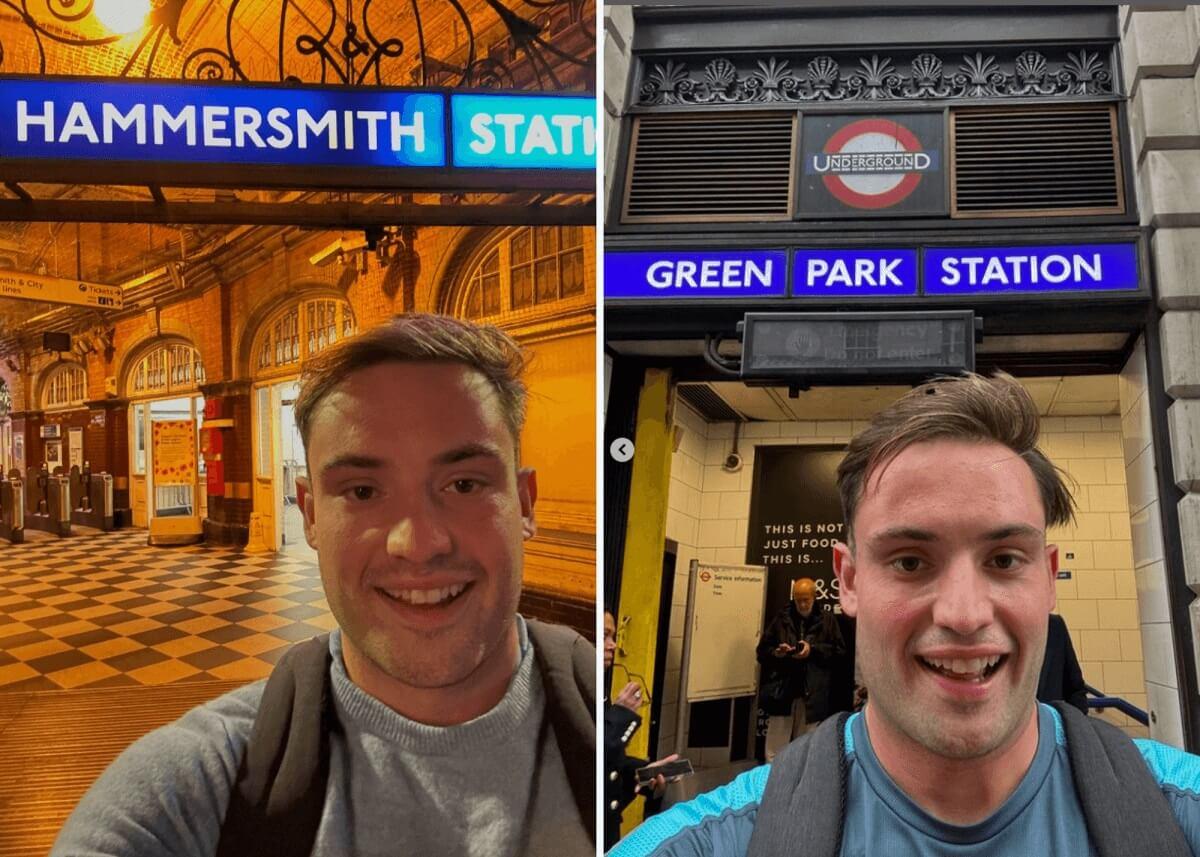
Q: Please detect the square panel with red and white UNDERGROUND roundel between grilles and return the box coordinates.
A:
[799,113,947,217]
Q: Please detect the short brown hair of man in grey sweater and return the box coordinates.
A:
[295,312,526,450]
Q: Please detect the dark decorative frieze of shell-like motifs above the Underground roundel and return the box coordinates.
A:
[637,47,1116,107]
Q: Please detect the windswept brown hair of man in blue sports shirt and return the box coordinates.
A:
[838,372,1075,545]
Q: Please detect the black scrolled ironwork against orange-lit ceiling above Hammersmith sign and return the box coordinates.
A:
[0,0,595,89]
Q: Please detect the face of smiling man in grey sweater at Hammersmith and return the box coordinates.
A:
[300,362,536,688]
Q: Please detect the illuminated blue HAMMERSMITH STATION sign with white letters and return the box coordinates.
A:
[0,77,596,183]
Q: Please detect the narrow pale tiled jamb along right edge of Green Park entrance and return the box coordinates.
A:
[1118,340,1183,748]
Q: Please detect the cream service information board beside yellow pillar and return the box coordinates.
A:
[684,561,767,702]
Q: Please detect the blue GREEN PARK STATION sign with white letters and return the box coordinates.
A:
[605,244,1140,300]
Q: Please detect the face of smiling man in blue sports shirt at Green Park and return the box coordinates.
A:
[834,441,1058,759]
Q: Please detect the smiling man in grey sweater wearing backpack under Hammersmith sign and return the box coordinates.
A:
[52,316,595,857]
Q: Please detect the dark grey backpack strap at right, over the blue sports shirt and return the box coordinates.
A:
[1054,702,1192,857]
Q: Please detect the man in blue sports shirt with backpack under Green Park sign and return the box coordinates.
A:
[612,374,1200,857]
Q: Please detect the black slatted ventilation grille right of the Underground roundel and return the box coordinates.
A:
[950,104,1124,217]
